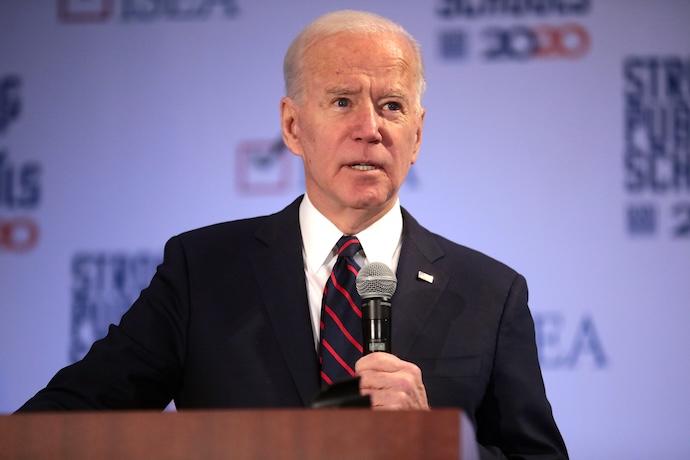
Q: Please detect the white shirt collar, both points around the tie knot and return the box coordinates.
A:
[299,194,403,272]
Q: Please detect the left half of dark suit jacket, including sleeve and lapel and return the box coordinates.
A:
[20,199,319,411]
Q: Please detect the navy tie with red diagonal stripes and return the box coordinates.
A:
[319,236,362,386]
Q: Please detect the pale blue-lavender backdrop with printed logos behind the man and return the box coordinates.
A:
[0,0,690,460]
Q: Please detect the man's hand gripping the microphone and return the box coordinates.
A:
[355,352,429,410]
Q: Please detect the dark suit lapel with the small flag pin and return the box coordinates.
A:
[391,209,449,359]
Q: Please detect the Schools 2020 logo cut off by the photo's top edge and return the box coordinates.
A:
[436,0,591,62]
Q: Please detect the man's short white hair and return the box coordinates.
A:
[283,10,426,104]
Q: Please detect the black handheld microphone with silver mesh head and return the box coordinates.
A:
[355,262,398,355]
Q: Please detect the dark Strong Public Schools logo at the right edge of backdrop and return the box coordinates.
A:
[623,56,690,239]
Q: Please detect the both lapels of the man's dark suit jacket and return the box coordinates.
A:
[246,198,449,406]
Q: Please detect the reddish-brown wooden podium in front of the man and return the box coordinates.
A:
[0,409,478,460]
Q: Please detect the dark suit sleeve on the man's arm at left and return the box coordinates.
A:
[19,238,188,412]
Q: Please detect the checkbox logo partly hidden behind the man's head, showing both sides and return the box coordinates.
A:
[235,136,419,196]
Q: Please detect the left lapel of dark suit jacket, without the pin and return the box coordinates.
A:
[252,198,319,406]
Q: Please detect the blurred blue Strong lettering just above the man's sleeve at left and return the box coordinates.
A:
[69,252,161,362]
